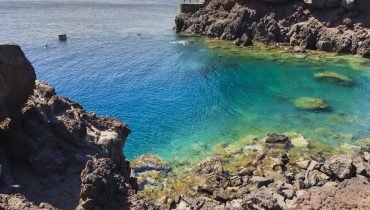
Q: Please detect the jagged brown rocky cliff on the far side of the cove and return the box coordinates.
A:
[175,0,370,57]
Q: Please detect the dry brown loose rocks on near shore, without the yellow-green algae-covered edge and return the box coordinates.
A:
[170,134,370,210]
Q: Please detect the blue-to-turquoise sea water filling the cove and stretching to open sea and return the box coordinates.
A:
[0,0,370,160]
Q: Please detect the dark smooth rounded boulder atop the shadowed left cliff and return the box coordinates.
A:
[0,44,36,122]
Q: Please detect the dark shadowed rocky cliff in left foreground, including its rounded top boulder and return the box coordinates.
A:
[0,45,151,210]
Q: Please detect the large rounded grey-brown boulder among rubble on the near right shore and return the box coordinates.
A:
[322,155,356,180]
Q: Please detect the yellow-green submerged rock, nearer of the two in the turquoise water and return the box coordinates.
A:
[294,97,330,111]
